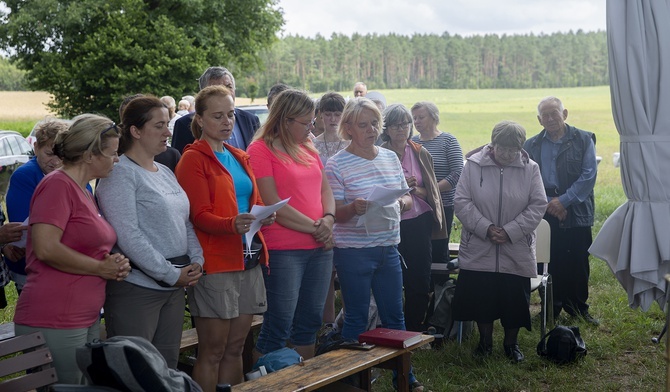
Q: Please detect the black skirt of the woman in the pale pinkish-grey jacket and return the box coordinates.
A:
[452,270,531,331]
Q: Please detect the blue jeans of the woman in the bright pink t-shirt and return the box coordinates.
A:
[256,248,333,354]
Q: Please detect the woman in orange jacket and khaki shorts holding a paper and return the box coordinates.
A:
[176,86,275,391]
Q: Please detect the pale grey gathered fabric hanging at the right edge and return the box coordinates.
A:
[589,0,670,311]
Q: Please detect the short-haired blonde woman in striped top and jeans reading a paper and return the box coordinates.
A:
[326,97,424,392]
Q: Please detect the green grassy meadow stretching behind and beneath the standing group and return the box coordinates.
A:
[0,86,666,392]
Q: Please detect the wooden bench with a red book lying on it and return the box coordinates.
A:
[233,335,434,392]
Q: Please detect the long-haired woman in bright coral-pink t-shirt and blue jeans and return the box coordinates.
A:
[247,89,335,358]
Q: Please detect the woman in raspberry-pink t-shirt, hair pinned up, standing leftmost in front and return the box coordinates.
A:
[14,114,130,384]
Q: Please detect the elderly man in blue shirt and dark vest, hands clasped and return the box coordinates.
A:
[524,97,599,325]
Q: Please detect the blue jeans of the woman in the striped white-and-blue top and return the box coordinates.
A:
[333,246,405,339]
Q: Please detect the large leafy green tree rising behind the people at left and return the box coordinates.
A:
[0,0,283,118]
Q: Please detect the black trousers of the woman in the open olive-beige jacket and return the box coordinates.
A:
[398,212,433,332]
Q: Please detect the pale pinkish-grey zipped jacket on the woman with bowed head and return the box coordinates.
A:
[454,145,547,278]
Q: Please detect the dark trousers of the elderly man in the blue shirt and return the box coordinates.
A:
[544,214,593,316]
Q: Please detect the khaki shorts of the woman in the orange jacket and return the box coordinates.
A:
[186,265,267,320]
